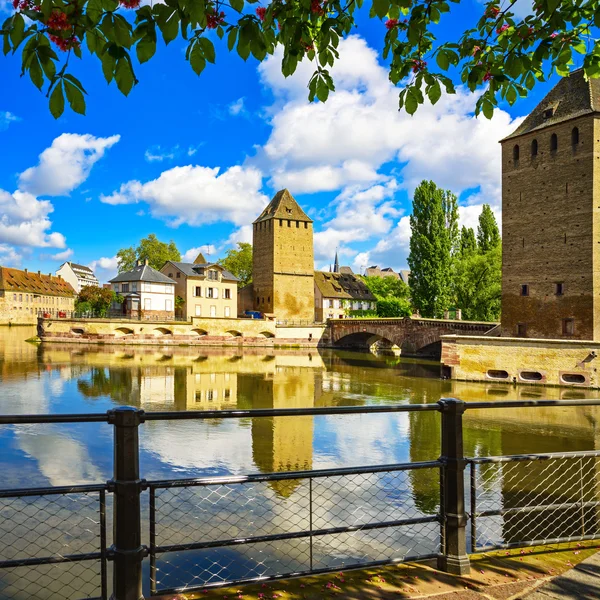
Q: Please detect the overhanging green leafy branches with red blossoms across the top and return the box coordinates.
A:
[1,0,600,118]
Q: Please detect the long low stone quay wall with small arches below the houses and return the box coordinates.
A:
[38,317,328,347]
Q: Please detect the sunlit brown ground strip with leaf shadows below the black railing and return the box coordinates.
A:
[155,541,600,600]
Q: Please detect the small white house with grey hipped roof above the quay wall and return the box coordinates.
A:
[110,260,175,320]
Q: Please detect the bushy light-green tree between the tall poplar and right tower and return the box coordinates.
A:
[453,244,502,321]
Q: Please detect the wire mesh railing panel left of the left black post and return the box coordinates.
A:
[0,491,106,600]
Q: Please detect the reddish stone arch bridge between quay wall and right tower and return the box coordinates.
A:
[328,317,500,357]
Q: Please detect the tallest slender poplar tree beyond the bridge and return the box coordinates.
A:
[408,181,459,317]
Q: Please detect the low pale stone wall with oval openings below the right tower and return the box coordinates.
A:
[441,335,600,388]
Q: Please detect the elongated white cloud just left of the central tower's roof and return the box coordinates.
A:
[100,165,268,226]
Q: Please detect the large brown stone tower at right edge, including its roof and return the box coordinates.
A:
[502,70,600,340]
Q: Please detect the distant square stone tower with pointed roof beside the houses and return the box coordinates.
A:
[252,190,315,322]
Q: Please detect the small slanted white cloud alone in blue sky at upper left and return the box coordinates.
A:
[19,133,121,196]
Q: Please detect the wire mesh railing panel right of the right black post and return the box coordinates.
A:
[467,453,600,551]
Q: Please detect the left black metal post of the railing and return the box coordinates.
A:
[108,406,146,600]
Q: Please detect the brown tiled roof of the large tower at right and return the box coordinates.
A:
[502,69,600,141]
